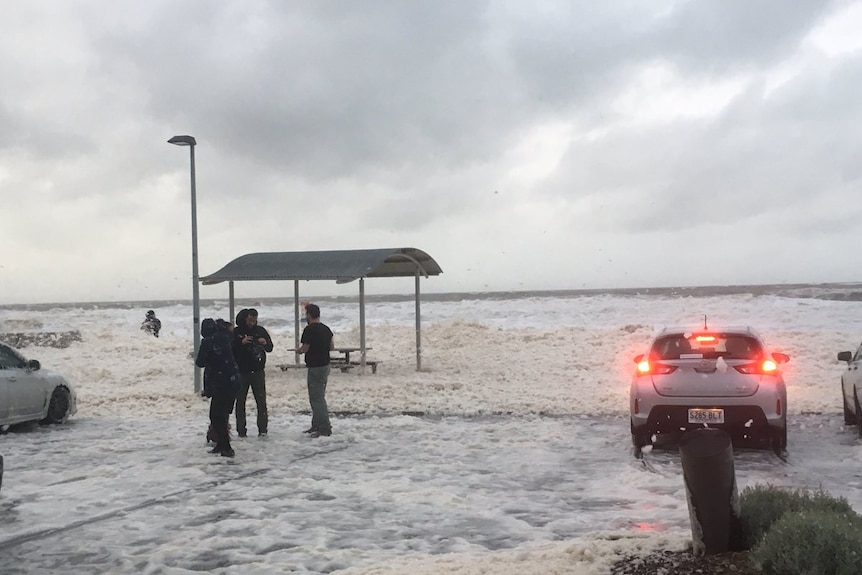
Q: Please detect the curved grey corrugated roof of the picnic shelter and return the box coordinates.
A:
[201,248,443,285]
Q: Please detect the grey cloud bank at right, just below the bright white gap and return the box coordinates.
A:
[608,52,862,232]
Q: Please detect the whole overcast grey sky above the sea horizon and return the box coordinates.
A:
[0,0,862,303]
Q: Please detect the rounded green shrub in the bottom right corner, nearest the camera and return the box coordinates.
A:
[751,510,862,575]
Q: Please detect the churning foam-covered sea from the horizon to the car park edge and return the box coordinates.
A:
[0,284,862,415]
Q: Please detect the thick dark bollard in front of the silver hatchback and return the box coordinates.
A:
[679,428,742,555]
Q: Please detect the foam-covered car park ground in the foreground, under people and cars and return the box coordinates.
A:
[0,414,862,574]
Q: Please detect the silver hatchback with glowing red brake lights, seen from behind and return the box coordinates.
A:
[630,327,790,451]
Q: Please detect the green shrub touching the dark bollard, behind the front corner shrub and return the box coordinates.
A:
[739,485,855,549]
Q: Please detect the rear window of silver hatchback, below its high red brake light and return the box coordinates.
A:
[652,333,761,359]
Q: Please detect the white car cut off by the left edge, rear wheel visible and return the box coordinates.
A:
[0,343,78,428]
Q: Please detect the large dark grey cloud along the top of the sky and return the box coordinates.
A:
[89,1,826,178]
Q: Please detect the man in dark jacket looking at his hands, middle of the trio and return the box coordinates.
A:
[233,309,272,437]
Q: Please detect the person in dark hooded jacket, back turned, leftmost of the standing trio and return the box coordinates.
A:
[195,318,240,457]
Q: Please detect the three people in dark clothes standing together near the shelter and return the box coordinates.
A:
[195,304,334,457]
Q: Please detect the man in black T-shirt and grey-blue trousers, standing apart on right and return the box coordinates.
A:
[299,303,335,437]
